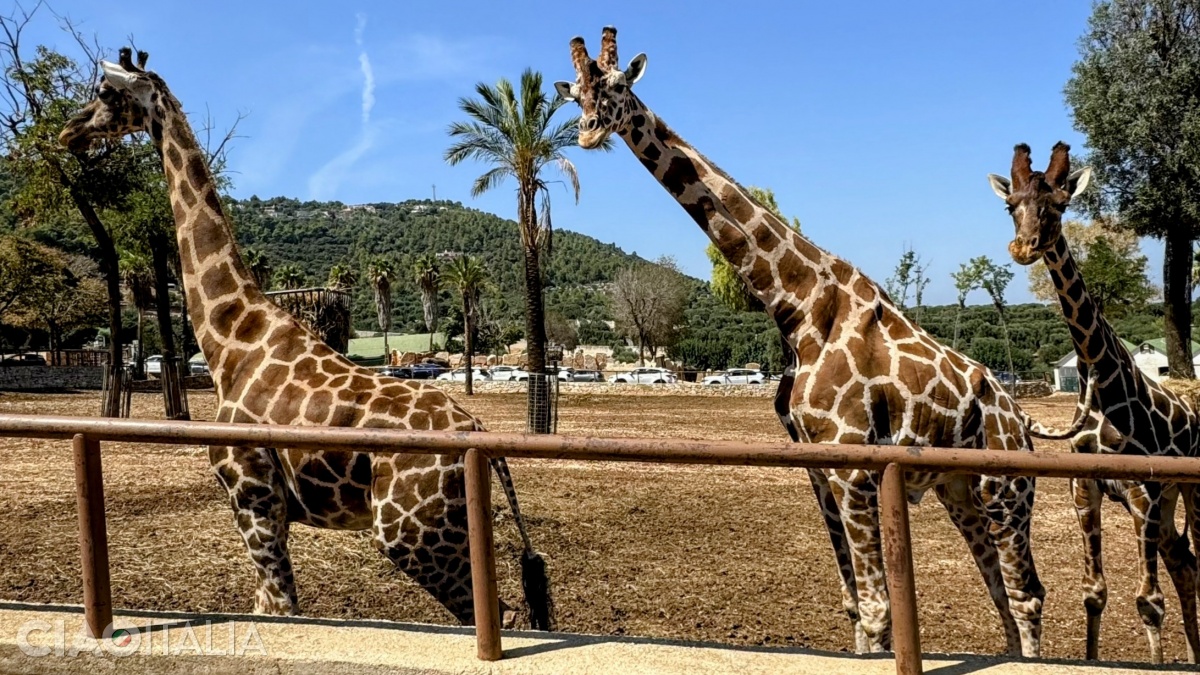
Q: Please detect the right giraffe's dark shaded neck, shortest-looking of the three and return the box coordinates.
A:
[1045,235,1141,407]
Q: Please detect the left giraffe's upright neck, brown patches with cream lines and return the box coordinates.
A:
[151,95,277,384]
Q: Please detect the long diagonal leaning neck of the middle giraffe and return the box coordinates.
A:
[622,96,852,336]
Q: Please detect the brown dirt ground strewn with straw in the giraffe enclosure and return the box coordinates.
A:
[0,392,1186,661]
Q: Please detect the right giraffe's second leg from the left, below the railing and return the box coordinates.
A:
[1126,482,1166,663]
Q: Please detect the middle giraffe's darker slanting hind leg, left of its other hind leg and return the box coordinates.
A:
[936,476,1021,656]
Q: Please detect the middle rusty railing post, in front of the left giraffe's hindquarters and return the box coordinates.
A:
[466,448,502,661]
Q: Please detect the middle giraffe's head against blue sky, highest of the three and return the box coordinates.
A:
[554,26,646,149]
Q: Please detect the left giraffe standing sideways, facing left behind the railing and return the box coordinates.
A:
[59,48,552,628]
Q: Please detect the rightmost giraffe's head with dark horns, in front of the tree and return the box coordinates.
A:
[988,141,1092,265]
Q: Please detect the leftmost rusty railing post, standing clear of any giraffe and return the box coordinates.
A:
[72,434,113,638]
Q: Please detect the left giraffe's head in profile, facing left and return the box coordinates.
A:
[59,47,170,151]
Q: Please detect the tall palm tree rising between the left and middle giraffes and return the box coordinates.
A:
[445,68,611,434]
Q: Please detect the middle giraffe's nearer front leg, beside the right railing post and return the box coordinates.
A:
[829,470,892,653]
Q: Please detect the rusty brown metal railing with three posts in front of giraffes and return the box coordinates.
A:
[0,414,1200,675]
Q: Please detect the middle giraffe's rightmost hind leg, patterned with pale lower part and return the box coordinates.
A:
[979,476,1046,658]
